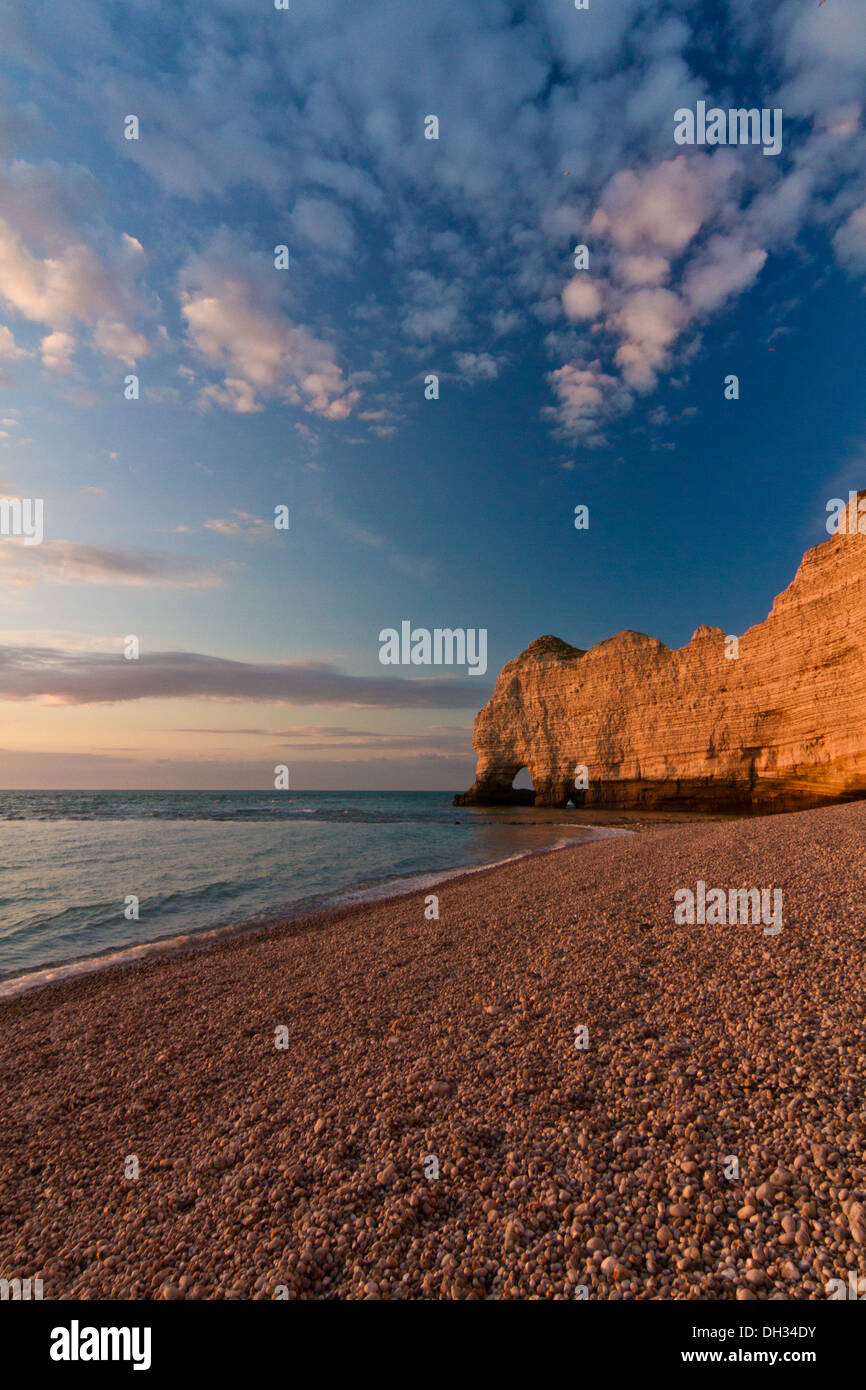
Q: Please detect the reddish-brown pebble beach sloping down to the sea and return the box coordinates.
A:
[0,802,866,1300]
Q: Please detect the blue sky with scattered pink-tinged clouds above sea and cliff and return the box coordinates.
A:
[0,0,866,791]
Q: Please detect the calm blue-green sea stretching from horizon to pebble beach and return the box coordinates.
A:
[0,791,610,992]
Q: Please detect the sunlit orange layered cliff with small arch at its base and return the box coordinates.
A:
[456,508,866,810]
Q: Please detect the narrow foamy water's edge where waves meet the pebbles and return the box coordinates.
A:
[0,823,635,1005]
